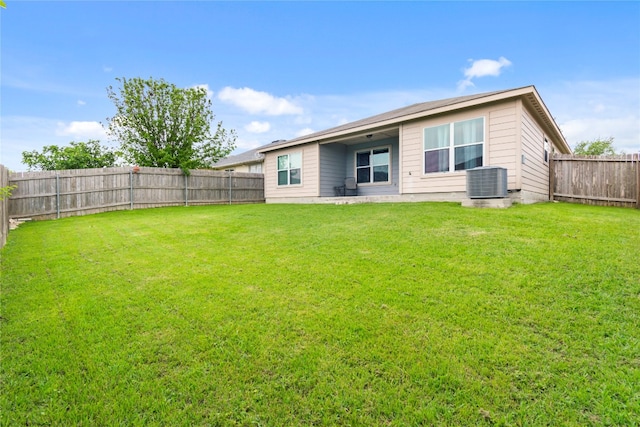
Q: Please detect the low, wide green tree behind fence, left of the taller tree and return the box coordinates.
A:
[22,140,118,170]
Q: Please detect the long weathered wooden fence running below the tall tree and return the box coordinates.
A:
[8,167,264,219]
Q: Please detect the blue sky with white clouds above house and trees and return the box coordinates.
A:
[0,0,640,171]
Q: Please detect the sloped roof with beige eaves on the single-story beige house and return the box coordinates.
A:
[258,86,571,153]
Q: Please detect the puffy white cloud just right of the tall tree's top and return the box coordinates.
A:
[218,86,303,116]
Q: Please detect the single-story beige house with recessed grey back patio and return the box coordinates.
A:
[257,86,571,203]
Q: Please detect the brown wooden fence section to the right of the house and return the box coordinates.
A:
[549,154,640,209]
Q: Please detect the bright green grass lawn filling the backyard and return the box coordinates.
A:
[0,203,640,426]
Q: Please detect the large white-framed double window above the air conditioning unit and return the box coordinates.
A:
[424,117,484,173]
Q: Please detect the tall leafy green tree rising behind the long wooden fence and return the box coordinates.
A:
[107,78,236,174]
